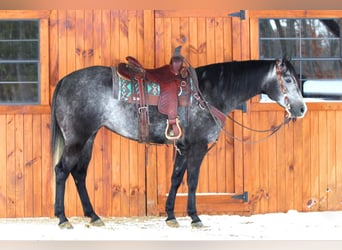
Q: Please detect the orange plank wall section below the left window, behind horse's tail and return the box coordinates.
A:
[0,113,53,217]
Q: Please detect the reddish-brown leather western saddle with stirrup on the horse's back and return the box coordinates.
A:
[117,46,191,142]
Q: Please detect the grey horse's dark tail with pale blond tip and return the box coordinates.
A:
[51,79,64,167]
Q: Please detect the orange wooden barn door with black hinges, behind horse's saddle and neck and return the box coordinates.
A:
[146,10,249,215]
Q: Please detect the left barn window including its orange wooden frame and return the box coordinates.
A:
[0,10,51,107]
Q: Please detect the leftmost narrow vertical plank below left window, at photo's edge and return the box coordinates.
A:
[0,115,8,218]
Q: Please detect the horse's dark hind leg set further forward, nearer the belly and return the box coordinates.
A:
[71,136,104,226]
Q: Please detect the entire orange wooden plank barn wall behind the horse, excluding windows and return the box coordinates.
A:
[0,10,342,217]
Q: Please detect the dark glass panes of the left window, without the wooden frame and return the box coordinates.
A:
[0,20,40,104]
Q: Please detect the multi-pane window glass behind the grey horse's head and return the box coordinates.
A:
[259,18,342,100]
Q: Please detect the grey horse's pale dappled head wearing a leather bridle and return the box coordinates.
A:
[266,59,307,118]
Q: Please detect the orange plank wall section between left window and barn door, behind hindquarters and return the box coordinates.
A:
[50,10,155,216]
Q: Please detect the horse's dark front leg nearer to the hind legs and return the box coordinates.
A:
[165,146,187,227]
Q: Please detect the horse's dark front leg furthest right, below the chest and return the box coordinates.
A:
[187,144,208,227]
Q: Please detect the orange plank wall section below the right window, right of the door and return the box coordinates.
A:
[244,105,342,213]
